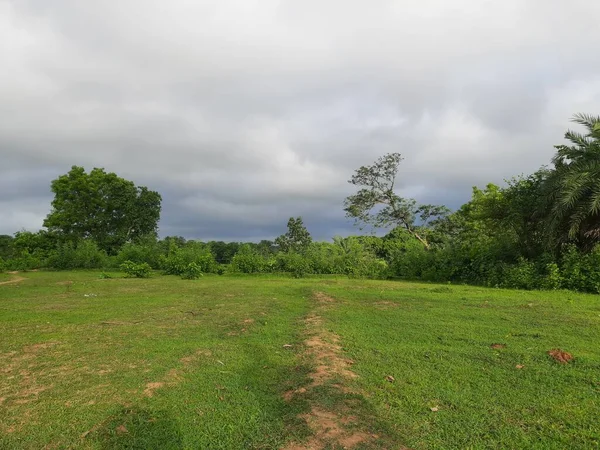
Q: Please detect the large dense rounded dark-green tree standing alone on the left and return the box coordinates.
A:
[44,166,162,254]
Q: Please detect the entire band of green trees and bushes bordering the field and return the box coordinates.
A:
[0,115,600,293]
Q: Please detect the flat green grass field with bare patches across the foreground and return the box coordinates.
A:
[0,272,600,450]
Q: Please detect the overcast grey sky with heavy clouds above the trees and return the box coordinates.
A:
[0,0,600,241]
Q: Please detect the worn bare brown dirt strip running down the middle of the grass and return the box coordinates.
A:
[283,292,377,450]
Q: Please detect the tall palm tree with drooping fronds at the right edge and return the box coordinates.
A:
[545,114,600,249]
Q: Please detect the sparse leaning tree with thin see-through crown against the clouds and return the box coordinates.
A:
[344,153,449,249]
